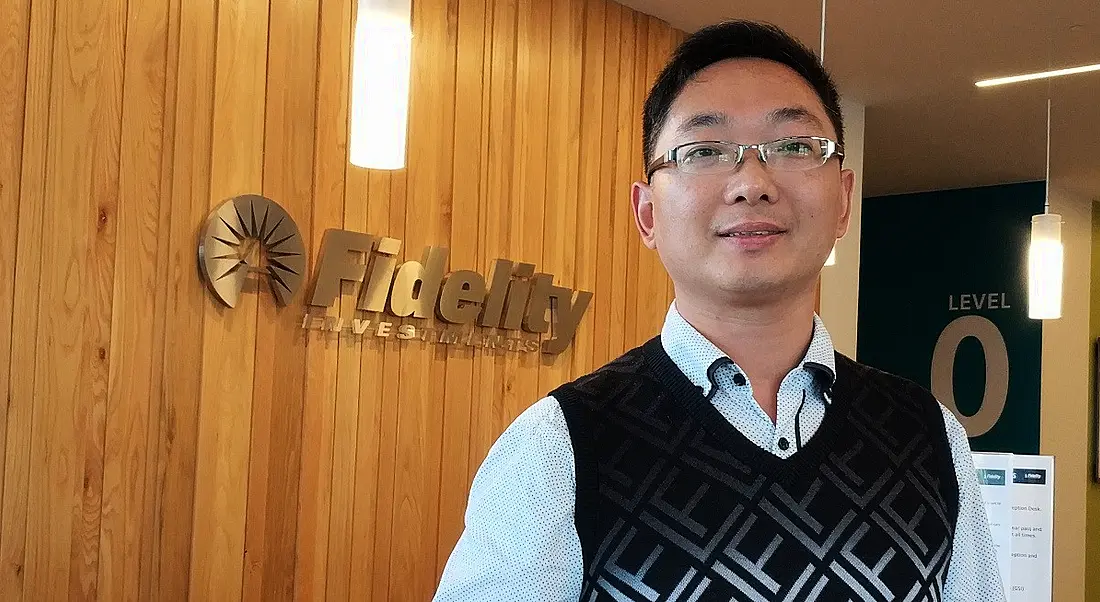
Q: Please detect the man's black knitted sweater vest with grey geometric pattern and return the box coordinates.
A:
[552,338,958,602]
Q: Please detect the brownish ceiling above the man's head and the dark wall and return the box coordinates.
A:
[620,0,1100,198]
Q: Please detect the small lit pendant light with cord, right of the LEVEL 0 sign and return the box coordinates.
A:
[1027,99,1065,320]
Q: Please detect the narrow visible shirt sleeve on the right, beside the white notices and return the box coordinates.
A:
[939,404,1005,602]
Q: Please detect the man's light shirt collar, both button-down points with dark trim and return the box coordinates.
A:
[661,302,836,396]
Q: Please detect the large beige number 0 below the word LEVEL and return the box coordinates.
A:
[932,316,1009,437]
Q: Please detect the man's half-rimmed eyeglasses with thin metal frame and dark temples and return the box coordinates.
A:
[646,135,844,180]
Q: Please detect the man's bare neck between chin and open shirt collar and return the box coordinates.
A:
[675,288,814,420]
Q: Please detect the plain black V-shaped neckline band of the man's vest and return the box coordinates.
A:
[642,336,854,474]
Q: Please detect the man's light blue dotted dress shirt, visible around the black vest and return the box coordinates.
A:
[435,304,1005,602]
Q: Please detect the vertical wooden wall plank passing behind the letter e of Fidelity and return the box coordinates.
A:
[432,0,487,584]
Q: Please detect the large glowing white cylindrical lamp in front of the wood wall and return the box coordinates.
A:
[348,0,413,169]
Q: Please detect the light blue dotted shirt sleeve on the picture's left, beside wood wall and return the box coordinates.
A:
[435,397,584,602]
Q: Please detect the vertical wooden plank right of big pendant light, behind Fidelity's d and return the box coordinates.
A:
[389,0,458,601]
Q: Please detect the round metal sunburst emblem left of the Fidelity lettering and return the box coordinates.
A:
[199,195,306,307]
